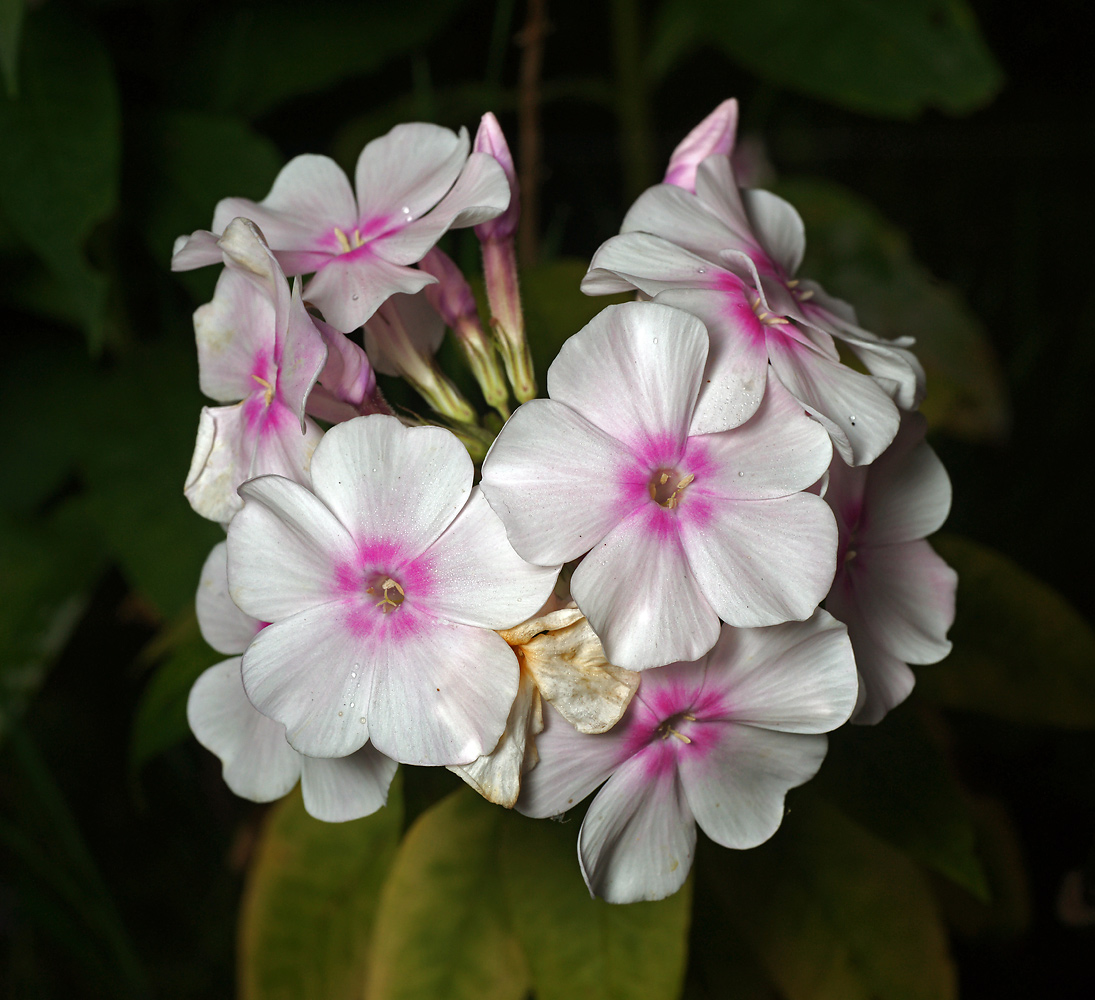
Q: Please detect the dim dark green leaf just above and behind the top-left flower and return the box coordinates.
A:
[148,112,284,266]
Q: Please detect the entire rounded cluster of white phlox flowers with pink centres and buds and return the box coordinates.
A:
[173,101,956,903]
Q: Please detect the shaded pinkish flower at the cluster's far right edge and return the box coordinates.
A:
[826,413,958,723]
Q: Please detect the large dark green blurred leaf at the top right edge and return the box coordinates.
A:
[647,0,1003,118]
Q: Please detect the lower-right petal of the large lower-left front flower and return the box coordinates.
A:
[368,607,520,765]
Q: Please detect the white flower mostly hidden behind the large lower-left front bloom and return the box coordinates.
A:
[186,542,396,823]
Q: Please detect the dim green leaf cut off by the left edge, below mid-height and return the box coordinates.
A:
[0,517,103,737]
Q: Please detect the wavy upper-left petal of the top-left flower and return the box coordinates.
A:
[212,153,357,257]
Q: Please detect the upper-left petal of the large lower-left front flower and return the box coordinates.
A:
[228,475,356,621]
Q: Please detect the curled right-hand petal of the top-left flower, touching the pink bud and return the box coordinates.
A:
[373,152,509,264]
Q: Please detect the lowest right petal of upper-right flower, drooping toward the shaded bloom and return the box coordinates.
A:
[768,335,900,465]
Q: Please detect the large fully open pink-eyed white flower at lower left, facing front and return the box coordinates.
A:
[228,415,557,765]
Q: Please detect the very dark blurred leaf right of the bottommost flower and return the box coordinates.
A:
[816,704,989,899]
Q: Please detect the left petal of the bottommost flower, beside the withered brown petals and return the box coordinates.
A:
[517,701,635,819]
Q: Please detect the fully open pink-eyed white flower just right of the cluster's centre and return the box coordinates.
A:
[482,302,837,670]
